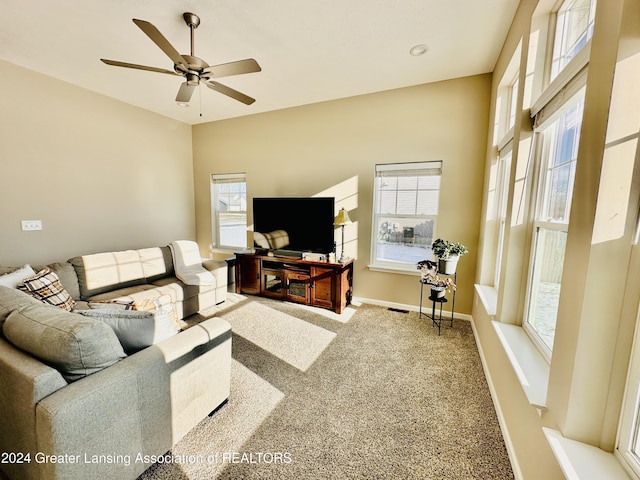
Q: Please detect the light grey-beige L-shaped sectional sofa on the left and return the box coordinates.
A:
[0,247,231,479]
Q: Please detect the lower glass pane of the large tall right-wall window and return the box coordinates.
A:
[527,228,567,351]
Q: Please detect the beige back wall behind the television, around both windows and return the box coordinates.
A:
[193,75,491,313]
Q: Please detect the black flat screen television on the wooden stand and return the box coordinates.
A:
[253,197,335,254]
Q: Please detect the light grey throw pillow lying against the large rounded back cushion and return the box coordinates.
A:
[78,308,178,355]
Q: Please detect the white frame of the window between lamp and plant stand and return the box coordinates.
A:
[368,160,443,274]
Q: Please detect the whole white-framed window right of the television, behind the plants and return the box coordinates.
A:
[371,161,442,271]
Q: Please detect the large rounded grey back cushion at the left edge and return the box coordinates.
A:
[3,304,126,382]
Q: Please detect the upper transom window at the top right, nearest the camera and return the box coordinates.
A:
[551,0,596,80]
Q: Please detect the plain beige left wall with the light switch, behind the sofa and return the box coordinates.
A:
[0,61,195,265]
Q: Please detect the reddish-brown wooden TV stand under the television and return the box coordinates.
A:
[236,253,353,313]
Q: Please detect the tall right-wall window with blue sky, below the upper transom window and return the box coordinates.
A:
[524,89,584,357]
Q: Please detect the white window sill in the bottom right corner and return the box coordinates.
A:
[542,427,631,480]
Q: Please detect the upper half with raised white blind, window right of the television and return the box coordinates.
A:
[375,161,442,216]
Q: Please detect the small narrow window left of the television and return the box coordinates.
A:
[211,173,247,249]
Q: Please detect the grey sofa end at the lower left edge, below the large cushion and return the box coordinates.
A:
[0,338,67,478]
